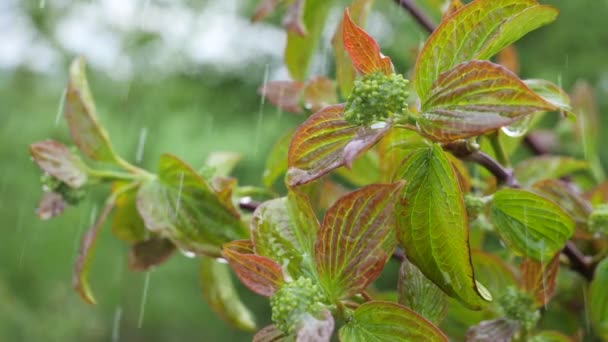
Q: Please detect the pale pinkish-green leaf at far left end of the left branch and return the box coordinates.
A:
[30,140,87,188]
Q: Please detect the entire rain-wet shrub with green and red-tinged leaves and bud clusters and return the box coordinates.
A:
[30,0,608,341]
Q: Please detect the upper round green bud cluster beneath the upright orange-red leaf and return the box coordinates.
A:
[344,72,409,125]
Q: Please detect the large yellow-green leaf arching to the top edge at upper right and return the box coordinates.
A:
[414,0,558,103]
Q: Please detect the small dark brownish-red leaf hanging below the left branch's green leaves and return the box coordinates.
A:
[128,236,175,271]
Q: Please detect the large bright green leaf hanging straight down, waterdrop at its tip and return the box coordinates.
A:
[396,144,485,309]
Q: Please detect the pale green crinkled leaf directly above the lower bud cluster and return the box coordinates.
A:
[251,192,319,279]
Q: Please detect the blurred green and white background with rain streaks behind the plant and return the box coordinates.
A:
[0,0,608,341]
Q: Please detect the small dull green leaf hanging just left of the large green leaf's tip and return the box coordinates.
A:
[397,260,448,324]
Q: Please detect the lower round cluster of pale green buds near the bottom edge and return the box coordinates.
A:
[270,277,326,334]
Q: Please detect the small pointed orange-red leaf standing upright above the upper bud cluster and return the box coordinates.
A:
[342,9,394,75]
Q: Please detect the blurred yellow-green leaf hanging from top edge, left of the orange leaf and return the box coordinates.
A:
[285,0,332,81]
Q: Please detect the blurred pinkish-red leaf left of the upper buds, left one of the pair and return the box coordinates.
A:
[258,81,304,113]
